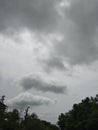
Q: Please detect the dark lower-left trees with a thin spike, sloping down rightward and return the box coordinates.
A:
[0,97,59,130]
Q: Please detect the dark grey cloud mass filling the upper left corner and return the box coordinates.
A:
[0,0,58,32]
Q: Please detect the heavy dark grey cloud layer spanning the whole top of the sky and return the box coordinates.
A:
[0,0,98,69]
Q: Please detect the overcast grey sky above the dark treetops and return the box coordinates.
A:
[0,0,98,123]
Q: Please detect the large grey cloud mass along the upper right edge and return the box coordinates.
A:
[56,0,98,64]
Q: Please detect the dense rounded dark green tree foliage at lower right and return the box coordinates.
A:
[58,95,98,130]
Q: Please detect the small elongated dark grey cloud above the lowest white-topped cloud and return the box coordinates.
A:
[20,77,66,93]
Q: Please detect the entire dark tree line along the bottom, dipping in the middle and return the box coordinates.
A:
[0,95,98,130]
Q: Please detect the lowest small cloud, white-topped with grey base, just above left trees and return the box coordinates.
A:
[7,92,55,109]
